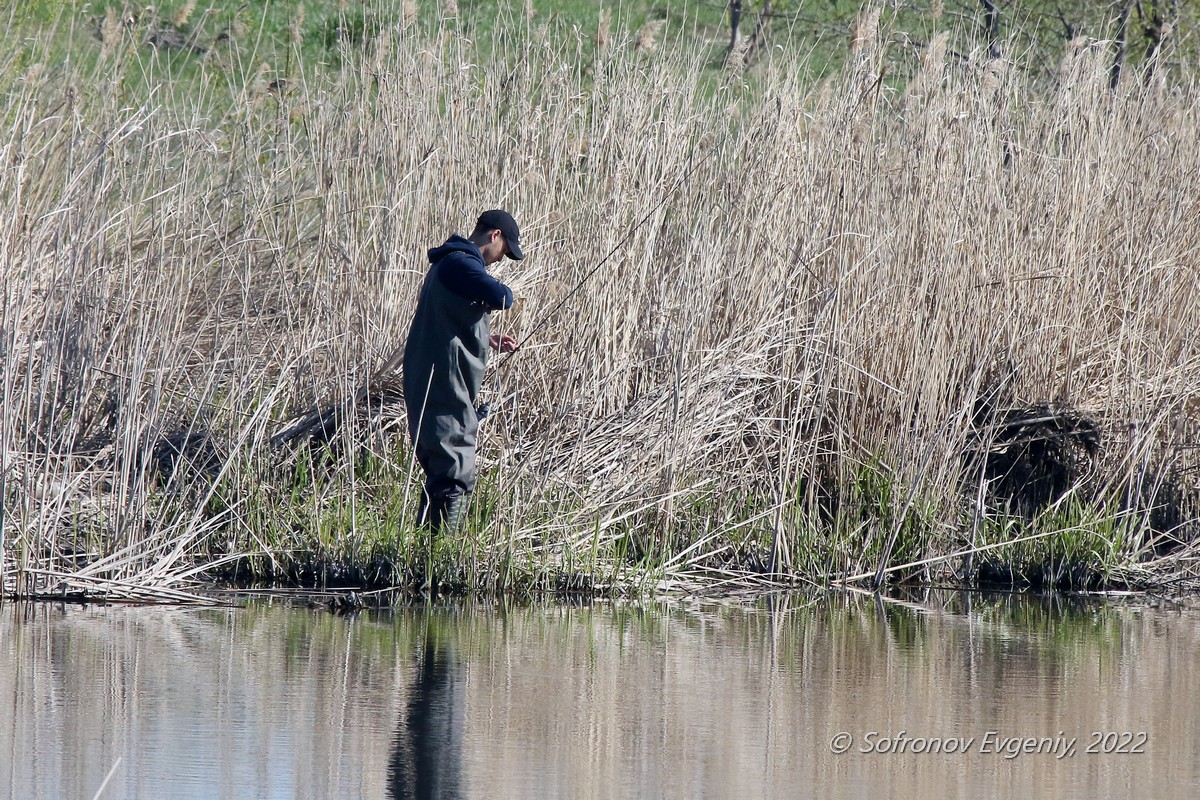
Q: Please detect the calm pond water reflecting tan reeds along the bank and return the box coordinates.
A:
[0,594,1200,800]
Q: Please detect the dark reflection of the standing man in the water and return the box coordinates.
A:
[388,628,466,800]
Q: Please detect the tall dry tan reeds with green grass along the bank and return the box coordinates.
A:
[0,3,1200,596]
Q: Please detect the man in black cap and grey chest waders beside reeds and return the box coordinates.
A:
[404,210,524,531]
